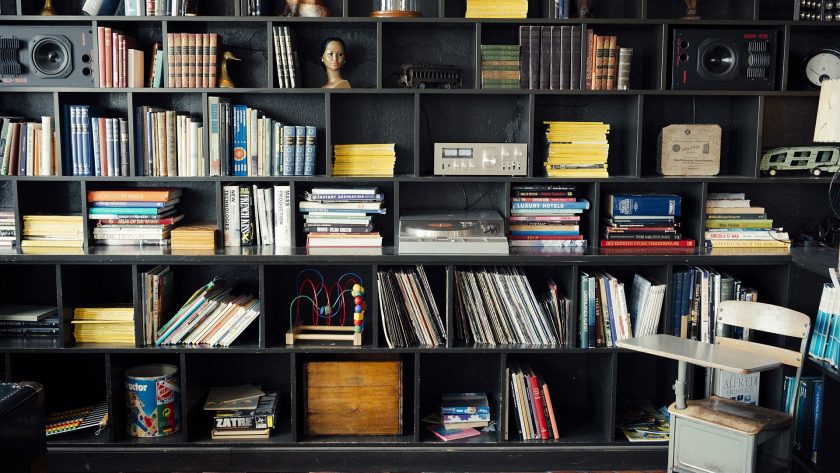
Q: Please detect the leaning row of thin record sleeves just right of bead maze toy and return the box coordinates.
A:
[377,265,446,348]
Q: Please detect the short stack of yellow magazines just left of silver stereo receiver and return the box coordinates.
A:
[333,143,397,177]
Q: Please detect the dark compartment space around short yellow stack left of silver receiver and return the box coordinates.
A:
[327,94,416,179]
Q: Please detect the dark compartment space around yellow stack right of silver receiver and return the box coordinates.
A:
[531,95,641,177]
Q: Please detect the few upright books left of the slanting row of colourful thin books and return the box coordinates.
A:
[140,266,175,345]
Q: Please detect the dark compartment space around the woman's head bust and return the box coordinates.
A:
[269,22,377,90]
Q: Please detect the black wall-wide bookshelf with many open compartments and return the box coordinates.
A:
[0,0,840,472]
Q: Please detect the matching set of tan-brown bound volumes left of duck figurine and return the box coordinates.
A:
[166,33,219,89]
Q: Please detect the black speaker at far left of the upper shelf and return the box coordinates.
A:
[0,26,95,88]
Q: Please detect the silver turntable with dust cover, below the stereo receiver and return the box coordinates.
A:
[399,210,508,255]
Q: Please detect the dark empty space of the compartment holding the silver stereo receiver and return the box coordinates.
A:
[418,93,533,179]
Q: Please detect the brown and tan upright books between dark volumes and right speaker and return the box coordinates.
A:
[585,30,633,90]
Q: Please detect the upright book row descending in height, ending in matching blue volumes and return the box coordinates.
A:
[207,96,318,176]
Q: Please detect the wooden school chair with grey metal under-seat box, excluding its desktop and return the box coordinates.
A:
[668,301,811,473]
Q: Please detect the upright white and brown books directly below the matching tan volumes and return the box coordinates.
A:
[134,106,208,177]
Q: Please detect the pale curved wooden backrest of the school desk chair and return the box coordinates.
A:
[715,301,811,413]
